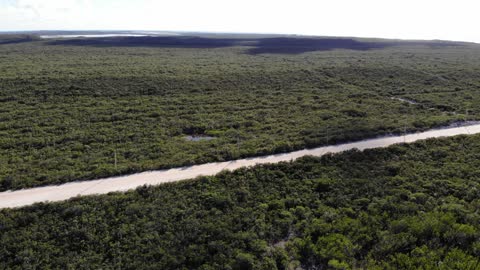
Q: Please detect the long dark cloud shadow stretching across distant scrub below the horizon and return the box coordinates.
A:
[48,36,464,55]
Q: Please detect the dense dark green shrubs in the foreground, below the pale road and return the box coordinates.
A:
[0,135,480,270]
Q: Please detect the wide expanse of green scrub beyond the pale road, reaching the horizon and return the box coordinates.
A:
[0,37,480,190]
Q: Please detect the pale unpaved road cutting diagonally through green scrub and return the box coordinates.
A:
[0,123,480,209]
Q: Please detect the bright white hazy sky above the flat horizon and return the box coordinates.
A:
[0,0,480,43]
